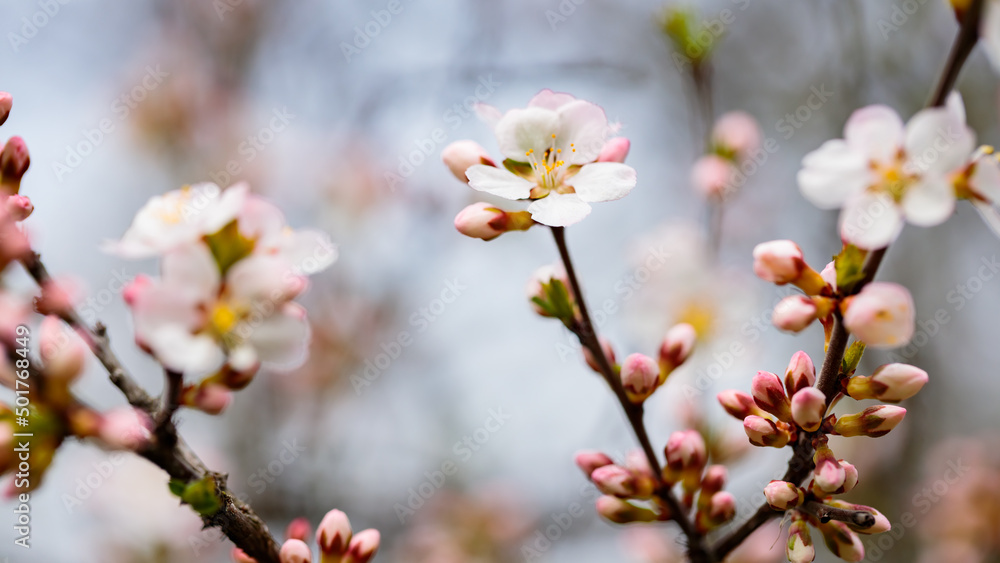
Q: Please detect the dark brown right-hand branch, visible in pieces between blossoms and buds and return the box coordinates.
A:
[714,0,983,557]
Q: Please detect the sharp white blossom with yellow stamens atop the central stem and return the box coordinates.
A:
[466,90,636,227]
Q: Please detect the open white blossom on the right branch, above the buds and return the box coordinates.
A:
[798,93,975,249]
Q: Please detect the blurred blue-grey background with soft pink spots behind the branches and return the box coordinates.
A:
[0,0,1000,563]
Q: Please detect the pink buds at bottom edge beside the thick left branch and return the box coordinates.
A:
[233,510,381,563]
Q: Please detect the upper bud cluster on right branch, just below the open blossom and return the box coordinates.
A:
[753,240,915,348]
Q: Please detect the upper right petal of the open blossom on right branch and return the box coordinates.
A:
[906,108,976,174]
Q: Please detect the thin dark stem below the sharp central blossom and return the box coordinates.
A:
[552,227,716,563]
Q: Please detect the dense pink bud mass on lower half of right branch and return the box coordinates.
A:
[718,351,927,563]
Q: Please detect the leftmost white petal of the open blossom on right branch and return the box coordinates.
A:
[797,139,872,209]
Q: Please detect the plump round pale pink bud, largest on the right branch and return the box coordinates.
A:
[844,282,915,348]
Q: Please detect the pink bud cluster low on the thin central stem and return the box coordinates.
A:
[576,430,736,533]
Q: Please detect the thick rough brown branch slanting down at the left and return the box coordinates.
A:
[21,253,279,563]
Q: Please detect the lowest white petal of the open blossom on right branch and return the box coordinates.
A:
[840,192,904,250]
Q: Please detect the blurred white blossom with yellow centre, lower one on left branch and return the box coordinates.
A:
[126,242,309,373]
